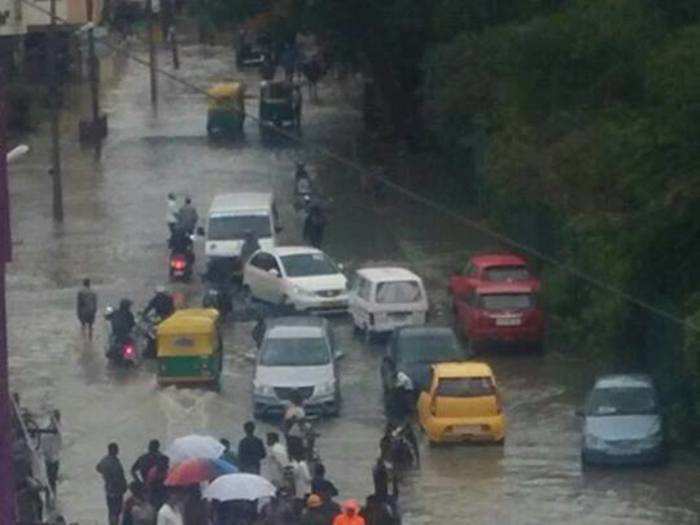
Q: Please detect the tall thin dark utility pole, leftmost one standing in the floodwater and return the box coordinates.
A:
[48,0,63,222]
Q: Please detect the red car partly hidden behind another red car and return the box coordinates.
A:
[449,253,540,302]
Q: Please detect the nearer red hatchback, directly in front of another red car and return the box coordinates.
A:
[454,282,544,352]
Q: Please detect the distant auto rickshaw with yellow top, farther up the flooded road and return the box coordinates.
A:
[207,82,245,137]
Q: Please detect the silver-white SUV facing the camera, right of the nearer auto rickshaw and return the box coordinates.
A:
[253,317,340,418]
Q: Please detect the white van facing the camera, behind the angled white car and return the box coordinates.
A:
[204,193,279,258]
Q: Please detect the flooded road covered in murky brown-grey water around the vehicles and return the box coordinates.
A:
[8,42,700,525]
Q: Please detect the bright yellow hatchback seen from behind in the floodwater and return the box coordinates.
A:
[418,362,506,444]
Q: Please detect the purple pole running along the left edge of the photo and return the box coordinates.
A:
[0,64,15,523]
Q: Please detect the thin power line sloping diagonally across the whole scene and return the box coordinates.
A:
[20,0,700,331]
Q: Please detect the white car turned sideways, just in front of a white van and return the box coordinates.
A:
[243,246,348,313]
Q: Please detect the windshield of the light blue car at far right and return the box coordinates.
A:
[586,387,658,416]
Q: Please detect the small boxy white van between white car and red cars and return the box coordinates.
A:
[349,268,428,335]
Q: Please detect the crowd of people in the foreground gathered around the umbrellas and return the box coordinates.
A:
[96,418,400,525]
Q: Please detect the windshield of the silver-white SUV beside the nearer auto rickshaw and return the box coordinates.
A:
[260,337,330,366]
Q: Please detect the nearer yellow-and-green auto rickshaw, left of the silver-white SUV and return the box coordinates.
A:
[156,308,223,390]
